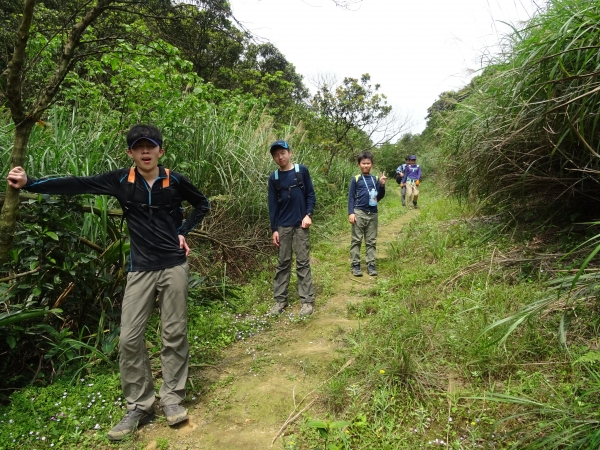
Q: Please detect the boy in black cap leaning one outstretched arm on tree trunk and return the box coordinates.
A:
[7,125,210,441]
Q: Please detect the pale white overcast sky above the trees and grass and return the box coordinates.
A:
[230,0,544,133]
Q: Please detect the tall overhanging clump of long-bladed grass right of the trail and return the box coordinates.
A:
[444,0,600,217]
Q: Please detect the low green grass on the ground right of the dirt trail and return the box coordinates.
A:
[284,185,600,449]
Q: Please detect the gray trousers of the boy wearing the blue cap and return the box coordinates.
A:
[273,227,315,303]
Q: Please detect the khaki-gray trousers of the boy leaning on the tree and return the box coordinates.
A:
[119,263,189,412]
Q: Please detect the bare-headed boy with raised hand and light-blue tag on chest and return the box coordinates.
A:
[348,152,387,277]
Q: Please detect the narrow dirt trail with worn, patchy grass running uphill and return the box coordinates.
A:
[139,211,416,450]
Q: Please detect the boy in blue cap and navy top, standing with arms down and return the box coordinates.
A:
[268,141,316,316]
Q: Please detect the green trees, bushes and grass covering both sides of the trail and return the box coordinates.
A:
[0,0,600,450]
